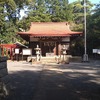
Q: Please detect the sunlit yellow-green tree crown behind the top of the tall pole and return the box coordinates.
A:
[72,0,93,24]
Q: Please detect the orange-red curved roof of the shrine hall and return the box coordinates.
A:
[18,22,82,37]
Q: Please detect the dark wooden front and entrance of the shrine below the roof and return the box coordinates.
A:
[30,37,70,57]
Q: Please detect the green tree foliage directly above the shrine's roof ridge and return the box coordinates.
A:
[25,0,73,22]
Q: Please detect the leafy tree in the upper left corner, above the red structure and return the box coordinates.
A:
[0,0,31,43]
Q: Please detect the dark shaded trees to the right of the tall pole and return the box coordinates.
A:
[87,4,100,54]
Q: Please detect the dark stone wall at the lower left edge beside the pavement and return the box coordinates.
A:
[0,57,9,100]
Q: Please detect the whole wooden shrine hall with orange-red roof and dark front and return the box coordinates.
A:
[17,22,82,56]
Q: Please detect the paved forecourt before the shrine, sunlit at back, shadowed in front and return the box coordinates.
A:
[7,61,100,100]
